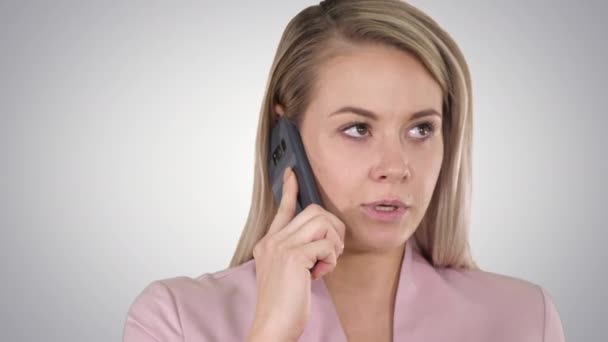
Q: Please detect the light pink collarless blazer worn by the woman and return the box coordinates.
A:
[123,239,565,342]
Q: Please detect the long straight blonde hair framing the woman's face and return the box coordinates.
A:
[230,0,478,269]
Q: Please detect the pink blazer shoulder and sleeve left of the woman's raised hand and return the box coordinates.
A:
[123,260,256,342]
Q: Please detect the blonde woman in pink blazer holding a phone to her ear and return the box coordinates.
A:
[124,0,564,342]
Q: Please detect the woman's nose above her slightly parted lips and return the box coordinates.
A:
[370,139,411,183]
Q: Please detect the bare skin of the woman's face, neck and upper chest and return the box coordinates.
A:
[275,45,444,341]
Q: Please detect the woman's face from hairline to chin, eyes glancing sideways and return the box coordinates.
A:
[288,45,443,252]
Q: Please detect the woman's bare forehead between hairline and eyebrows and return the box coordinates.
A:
[312,45,442,115]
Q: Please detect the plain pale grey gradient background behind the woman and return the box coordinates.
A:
[0,0,608,341]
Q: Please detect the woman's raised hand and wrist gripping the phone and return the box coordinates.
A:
[249,168,345,342]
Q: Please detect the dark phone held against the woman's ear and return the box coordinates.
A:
[268,116,322,215]
